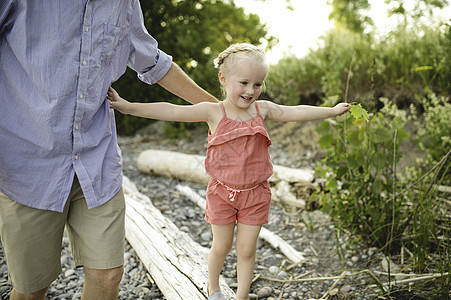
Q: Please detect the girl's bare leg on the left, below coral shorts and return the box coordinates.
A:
[208,222,235,295]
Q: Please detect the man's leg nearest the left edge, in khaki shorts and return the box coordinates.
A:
[0,193,66,299]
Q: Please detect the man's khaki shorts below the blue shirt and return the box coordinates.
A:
[0,180,125,293]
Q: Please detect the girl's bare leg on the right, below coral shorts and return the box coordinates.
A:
[235,223,261,300]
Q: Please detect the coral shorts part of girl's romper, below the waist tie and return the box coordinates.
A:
[205,178,271,225]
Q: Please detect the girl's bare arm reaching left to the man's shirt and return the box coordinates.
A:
[107,87,217,122]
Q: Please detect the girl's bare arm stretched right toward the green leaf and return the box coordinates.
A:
[259,101,351,122]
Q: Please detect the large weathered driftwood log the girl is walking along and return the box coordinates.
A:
[123,177,235,300]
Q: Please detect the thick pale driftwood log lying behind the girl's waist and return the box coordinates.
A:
[138,150,314,208]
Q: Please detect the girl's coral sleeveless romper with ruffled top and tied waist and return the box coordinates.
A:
[205,102,273,225]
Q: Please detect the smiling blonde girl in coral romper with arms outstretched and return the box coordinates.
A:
[107,44,351,300]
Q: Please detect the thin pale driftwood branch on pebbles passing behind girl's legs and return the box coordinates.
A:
[177,184,305,263]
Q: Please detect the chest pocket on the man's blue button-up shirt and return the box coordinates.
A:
[100,23,127,67]
